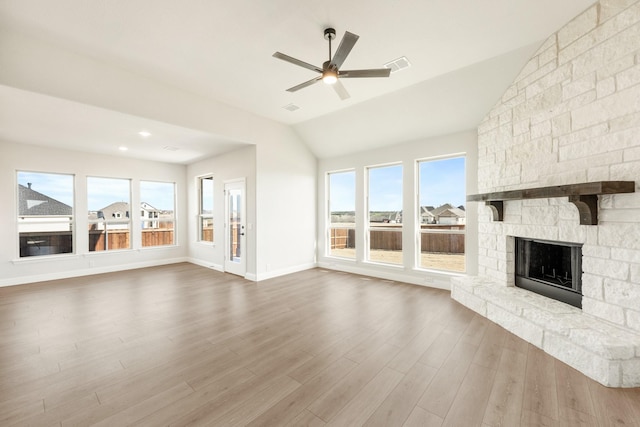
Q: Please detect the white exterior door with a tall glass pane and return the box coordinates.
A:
[224,179,247,277]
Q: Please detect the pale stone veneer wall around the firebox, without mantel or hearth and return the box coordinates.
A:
[478,0,640,331]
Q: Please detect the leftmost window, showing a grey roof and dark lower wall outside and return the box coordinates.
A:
[18,171,74,258]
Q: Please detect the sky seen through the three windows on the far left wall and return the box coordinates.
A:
[18,172,175,211]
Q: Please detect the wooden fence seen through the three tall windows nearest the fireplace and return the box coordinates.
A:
[330,225,465,254]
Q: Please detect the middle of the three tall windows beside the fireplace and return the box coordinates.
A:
[368,165,403,265]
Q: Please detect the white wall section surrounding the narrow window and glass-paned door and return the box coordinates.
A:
[187,146,256,277]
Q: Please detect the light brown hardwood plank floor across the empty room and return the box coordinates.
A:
[0,264,640,427]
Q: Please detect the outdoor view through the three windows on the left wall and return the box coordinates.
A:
[17,171,175,257]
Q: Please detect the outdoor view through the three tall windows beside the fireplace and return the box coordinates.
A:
[329,157,466,272]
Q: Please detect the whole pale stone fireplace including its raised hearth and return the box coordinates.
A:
[451,0,640,387]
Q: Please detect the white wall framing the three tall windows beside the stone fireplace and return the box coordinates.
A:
[317,131,478,289]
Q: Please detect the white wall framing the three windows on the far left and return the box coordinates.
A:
[0,141,188,286]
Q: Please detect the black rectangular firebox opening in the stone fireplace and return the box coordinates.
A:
[515,237,582,308]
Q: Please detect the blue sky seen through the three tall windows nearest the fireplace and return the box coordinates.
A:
[329,157,466,212]
